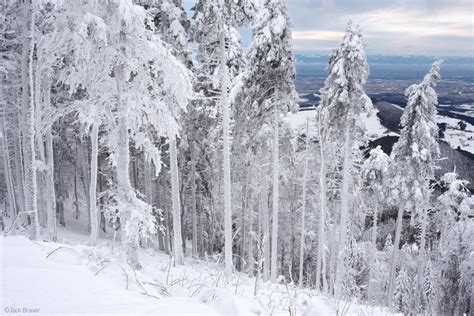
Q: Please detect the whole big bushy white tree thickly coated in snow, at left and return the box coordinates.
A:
[41,0,190,267]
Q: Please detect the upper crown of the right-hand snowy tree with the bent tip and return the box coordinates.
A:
[392,60,442,172]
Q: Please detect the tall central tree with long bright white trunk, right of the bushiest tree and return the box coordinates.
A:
[189,0,250,275]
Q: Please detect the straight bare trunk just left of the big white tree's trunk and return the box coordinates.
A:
[89,123,99,244]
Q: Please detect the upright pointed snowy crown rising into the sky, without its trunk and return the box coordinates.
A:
[321,21,372,136]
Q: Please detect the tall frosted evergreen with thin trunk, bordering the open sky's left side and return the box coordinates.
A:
[243,0,297,282]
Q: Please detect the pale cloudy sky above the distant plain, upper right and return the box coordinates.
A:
[184,0,474,56]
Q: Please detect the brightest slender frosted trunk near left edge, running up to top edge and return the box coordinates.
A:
[21,0,40,239]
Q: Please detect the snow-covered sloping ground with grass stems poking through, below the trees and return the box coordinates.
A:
[0,233,396,316]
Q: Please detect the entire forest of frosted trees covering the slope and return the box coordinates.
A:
[0,0,474,315]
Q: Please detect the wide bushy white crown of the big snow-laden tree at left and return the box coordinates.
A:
[38,0,192,170]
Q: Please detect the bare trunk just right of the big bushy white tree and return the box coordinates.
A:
[170,135,184,265]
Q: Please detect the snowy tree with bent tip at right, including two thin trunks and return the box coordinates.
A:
[387,61,442,306]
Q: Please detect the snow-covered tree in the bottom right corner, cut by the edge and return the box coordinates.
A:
[432,172,474,314]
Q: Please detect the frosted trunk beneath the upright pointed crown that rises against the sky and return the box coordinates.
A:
[334,122,352,298]
